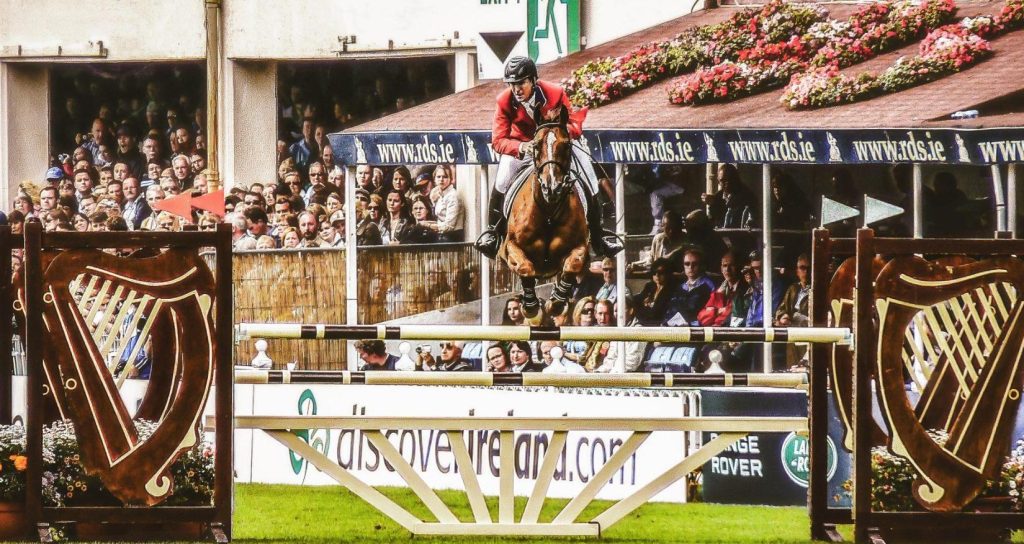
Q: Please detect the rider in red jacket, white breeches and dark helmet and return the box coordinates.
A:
[476,56,623,258]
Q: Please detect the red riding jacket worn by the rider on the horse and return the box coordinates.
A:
[490,80,587,158]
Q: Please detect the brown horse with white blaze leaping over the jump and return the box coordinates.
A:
[503,108,590,324]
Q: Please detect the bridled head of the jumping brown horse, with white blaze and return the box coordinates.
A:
[534,108,572,203]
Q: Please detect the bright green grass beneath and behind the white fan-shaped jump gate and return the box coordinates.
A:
[234,485,823,543]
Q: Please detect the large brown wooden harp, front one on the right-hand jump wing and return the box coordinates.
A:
[876,256,1024,511]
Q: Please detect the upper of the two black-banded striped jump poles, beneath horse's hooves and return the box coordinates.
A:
[237,323,853,345]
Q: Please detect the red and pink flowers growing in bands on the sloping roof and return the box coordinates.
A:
[562,0,1024,109]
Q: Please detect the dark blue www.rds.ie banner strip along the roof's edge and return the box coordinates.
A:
[330,128,1024,165]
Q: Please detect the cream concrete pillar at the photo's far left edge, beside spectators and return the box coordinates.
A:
[0,62,50,209]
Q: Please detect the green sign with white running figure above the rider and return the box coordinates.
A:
[526,0,580,62]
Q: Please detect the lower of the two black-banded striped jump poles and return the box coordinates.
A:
[234,367,807,388]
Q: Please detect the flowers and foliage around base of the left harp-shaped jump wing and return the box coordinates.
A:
[0,421,214,506]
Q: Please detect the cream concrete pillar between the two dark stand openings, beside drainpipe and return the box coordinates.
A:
[220,60,278,189]
